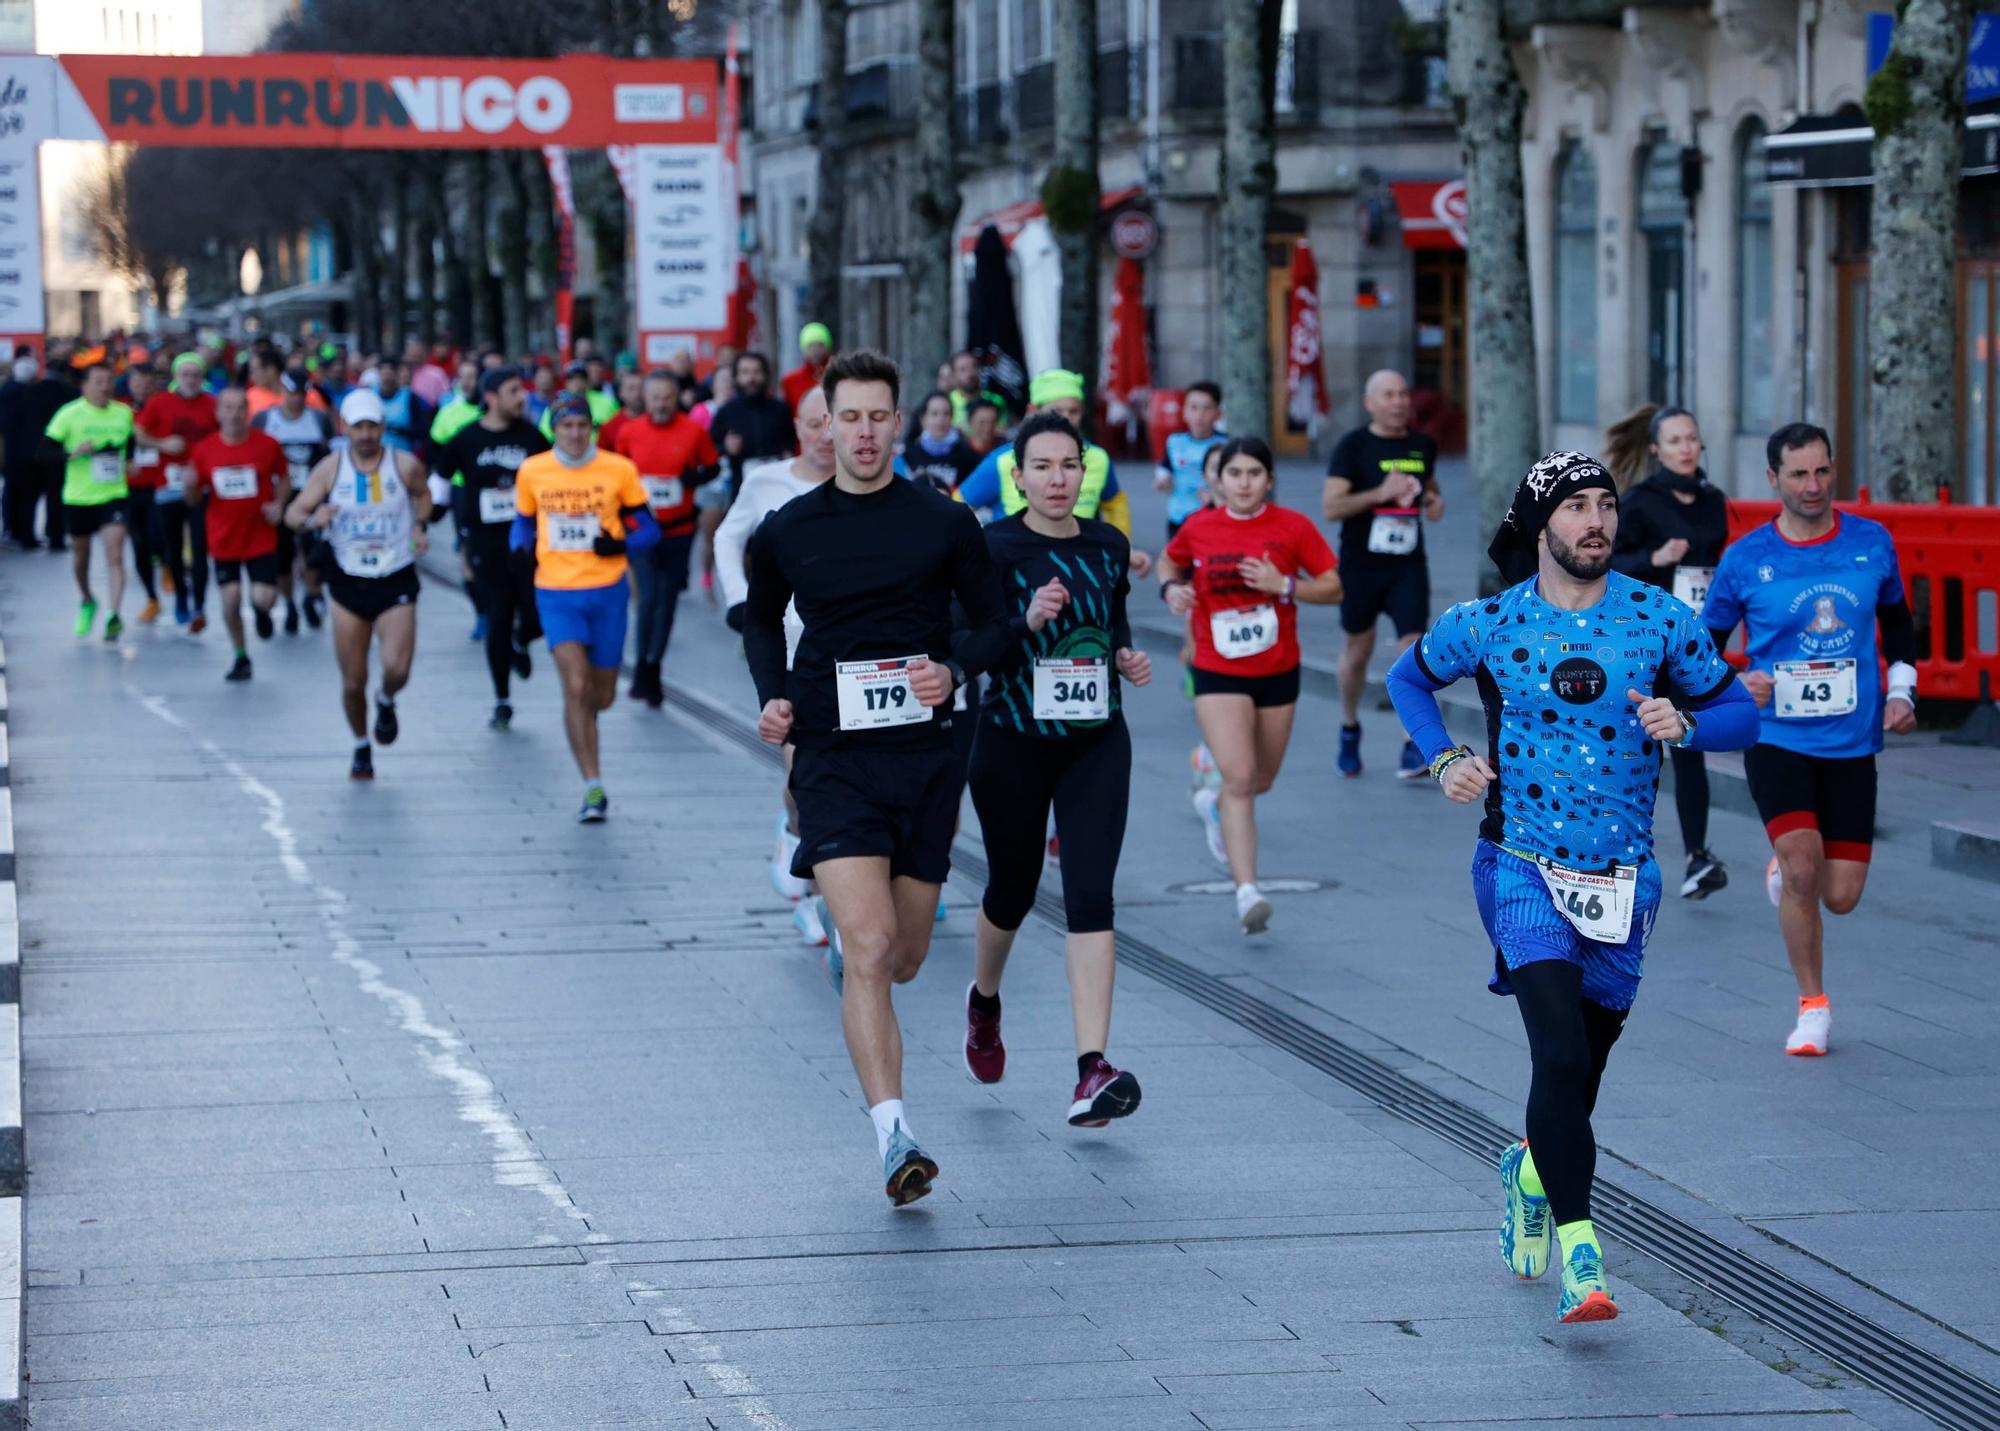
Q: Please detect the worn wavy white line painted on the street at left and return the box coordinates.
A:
[125,684,786,1431]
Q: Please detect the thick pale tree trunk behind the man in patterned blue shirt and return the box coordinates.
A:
[1446,0,1542,592]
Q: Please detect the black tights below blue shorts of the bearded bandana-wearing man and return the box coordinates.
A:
[1508,959,1626,1227]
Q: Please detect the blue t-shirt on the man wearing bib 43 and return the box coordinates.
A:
[1702,512,1906,759]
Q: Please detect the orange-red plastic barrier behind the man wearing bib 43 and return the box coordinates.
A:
[1730,498,2000,702]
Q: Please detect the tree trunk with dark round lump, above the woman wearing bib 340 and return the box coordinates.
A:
[1042,0,1096,379]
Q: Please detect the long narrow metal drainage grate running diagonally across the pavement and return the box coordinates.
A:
[666,688,2000,1431]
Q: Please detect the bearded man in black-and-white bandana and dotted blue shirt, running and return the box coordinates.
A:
[1388,452,1756,1321]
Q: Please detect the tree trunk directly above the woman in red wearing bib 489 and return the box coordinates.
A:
[1220,0,1280,436]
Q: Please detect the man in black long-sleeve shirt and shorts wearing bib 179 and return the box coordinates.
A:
[744,352,1008,1205]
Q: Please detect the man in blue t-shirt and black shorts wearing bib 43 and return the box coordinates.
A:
[1702,422,1916,1055]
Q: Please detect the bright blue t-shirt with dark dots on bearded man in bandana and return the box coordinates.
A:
[1416,572,1736,869]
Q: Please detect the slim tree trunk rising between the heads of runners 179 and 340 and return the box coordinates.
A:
[904,0,958,374]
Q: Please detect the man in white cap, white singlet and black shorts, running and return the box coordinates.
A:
[284,388,430,779]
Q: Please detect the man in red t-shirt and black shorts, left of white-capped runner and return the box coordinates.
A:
[186,388,292,682]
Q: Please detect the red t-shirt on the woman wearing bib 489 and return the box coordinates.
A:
[1166,504,1338,676]
